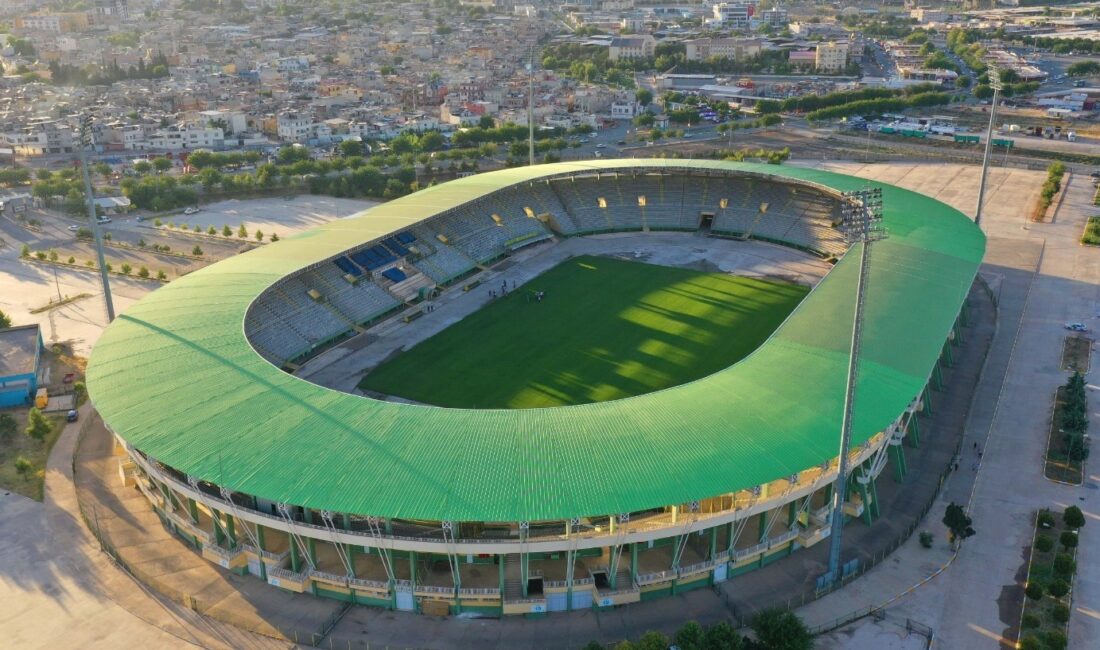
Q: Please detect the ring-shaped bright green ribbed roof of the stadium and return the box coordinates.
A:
[88,159,985,521]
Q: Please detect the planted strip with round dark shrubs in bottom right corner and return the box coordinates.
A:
[1019,508,1084,650]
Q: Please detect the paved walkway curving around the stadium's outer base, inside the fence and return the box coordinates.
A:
[68,276,992,648]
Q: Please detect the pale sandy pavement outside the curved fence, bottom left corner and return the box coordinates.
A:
[0,407,288,649]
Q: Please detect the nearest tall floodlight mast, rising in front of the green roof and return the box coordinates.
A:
[826,188,886,584]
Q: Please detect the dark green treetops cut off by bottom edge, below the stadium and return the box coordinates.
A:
[584,609,814,650]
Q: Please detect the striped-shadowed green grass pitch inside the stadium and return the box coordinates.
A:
[360,256,810,408]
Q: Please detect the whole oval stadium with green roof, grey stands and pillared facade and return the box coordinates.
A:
[87,159,985,616]
